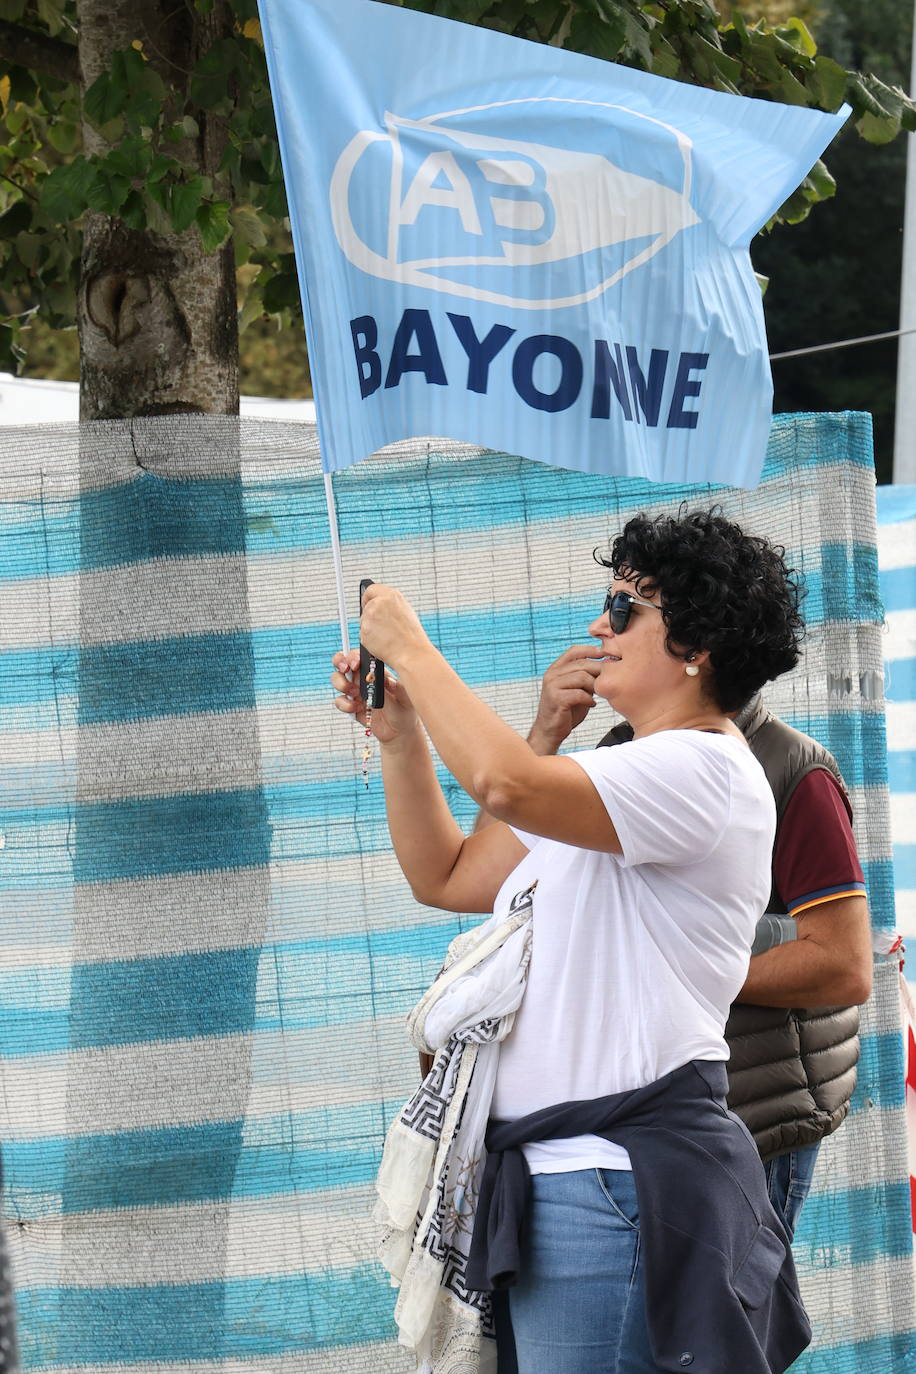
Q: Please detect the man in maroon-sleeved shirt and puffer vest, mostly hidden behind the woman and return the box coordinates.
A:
[478,644,872,1234]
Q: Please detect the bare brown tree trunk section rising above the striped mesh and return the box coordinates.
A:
[78,0,239,420]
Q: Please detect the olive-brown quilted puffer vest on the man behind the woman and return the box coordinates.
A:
[600,697,858,1160]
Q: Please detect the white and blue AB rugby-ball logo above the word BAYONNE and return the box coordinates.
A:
[331,104,698,311]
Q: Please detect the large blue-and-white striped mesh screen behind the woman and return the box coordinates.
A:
[0,415,916,1374]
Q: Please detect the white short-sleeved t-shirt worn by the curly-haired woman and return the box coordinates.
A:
[492,730,776,1173]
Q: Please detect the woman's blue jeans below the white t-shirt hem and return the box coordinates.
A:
[496,1169,658,1374]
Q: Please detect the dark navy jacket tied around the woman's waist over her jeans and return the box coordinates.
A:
[467,1059,812,1374]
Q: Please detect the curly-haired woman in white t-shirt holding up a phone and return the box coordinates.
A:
[331,511,806,1374]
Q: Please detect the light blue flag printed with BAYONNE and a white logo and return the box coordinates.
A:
[260,0,849,486]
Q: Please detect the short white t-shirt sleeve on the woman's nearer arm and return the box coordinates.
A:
[567,731,731,868]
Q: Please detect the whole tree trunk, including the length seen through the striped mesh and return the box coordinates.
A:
[66,8,271,1352]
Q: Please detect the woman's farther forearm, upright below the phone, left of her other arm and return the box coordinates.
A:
[382,725,464,905]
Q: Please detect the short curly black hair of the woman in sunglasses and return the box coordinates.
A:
[595,507,805,712]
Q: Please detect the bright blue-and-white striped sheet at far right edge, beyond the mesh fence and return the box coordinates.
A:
[878,485,916,992]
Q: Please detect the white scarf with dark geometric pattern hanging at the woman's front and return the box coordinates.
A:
[374,883,537,1374]
